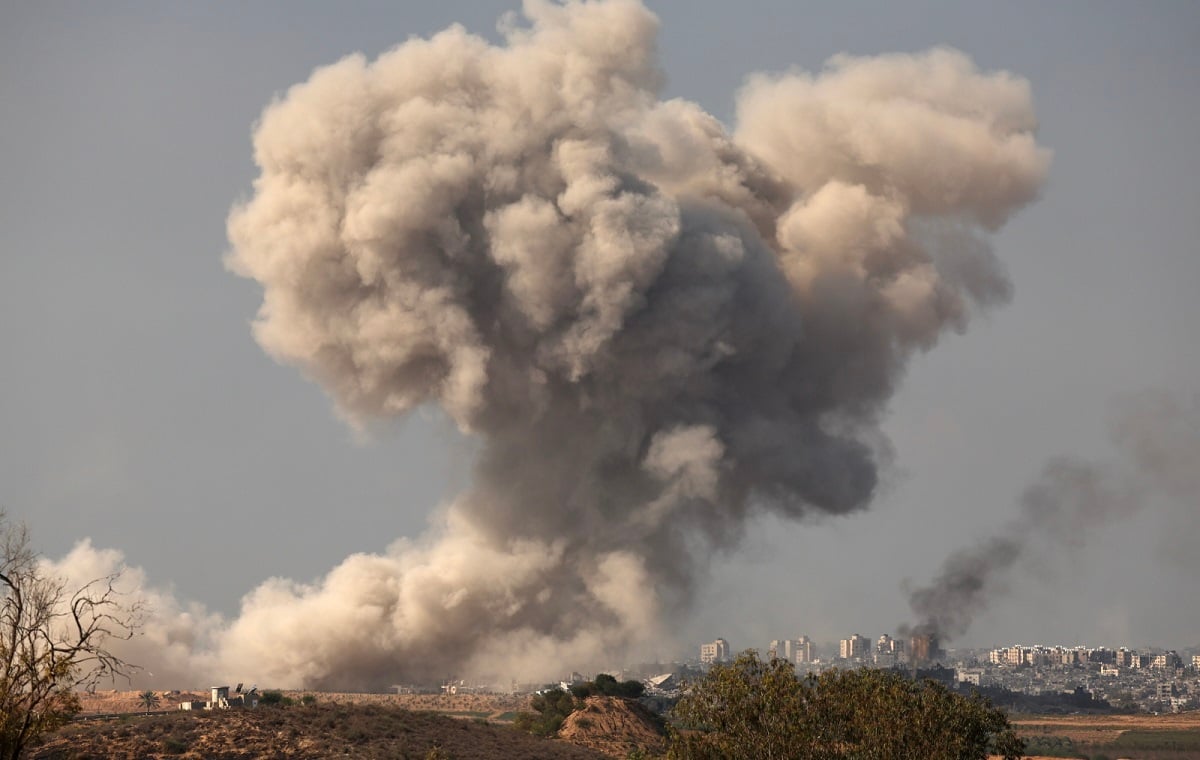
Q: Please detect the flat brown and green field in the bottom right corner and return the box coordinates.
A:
[1013,712,1200,760]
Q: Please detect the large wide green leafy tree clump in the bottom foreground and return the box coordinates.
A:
[668,650,1025,760]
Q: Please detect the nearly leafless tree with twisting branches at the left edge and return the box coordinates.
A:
[0,511,142,760]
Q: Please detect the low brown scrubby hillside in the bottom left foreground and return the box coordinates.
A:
[30,704,604,760]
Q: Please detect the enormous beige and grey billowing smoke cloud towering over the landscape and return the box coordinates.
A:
[58,0,1049,688]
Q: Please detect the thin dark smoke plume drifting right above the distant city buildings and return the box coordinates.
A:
[901,391,1200,640]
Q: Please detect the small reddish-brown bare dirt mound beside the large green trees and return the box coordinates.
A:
[558,696,666,758]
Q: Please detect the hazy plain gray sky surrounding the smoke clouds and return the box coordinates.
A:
[0,1,1200,654]
